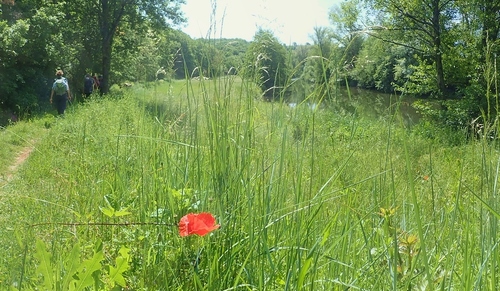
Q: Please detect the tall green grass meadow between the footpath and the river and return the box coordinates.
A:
[0,77,500,291]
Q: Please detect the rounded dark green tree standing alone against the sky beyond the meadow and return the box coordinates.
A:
[245,29,289,100]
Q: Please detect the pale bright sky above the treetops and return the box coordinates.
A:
[181,0,340,45]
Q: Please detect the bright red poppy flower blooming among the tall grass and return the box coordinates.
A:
[179,212,220,236]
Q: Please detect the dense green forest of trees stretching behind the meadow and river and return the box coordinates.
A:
[0,0,500,132]
